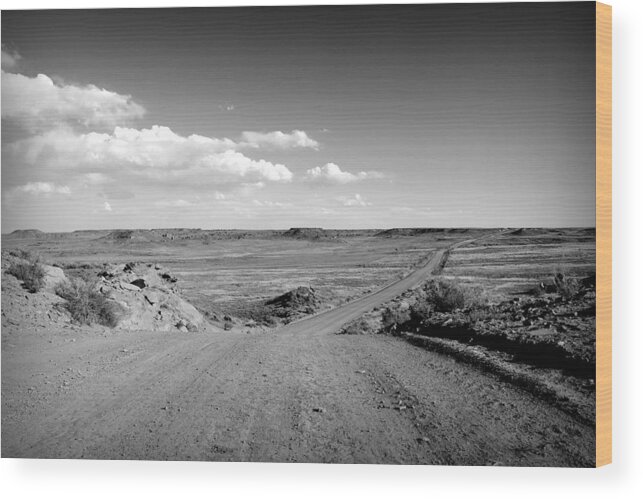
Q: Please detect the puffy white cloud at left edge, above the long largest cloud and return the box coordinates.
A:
[2,69,145,130]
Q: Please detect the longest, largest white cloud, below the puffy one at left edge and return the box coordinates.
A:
[7,126,293,185]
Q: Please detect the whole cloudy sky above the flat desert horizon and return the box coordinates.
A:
[1,2,595,233]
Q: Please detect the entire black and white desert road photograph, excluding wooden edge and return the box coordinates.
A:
[1,2,597,468]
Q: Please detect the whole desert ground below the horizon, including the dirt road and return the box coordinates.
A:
[2,228,595,466]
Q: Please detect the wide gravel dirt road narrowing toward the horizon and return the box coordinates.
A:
[2,236,594,466]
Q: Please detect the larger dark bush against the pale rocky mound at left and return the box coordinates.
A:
[56,278,121,327]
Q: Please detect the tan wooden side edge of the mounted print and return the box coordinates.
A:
[596,2,612,467]
